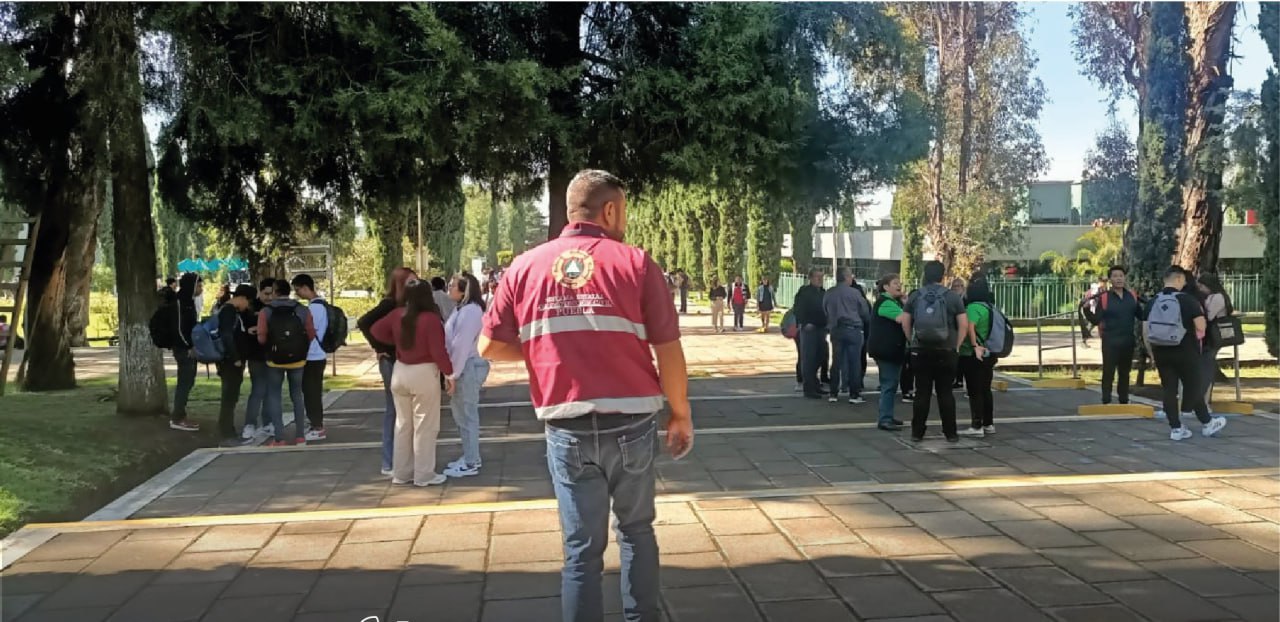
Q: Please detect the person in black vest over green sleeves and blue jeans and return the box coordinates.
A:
[867,274,906,431]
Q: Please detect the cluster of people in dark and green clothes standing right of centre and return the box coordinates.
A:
[783,261,1002,442]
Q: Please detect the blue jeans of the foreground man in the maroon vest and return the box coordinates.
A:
[547,415,662,622]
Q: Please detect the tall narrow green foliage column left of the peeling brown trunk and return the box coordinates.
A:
[1125,3,1189,292]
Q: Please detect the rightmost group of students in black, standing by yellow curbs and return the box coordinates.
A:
[1080,265,1243,440]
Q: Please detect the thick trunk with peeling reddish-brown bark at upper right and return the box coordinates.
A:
[1175,1,1236,271]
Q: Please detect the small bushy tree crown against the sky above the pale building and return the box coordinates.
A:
[1080,116,1138,221]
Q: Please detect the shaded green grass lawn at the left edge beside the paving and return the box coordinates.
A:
[0,370,381,538]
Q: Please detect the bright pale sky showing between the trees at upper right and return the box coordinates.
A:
[860,3,1270,223]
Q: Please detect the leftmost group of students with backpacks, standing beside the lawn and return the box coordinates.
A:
[152,273,344,447]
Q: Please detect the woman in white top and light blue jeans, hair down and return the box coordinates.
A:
[444,273,489,477]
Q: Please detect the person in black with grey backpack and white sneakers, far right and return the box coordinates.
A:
[1143,266,1226,440]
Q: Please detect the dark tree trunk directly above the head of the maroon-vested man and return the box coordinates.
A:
[543,3,586,239]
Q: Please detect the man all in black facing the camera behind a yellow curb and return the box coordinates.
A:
[1080,266,1142,404]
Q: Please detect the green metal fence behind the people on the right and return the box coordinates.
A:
[778,274,1262,320]
